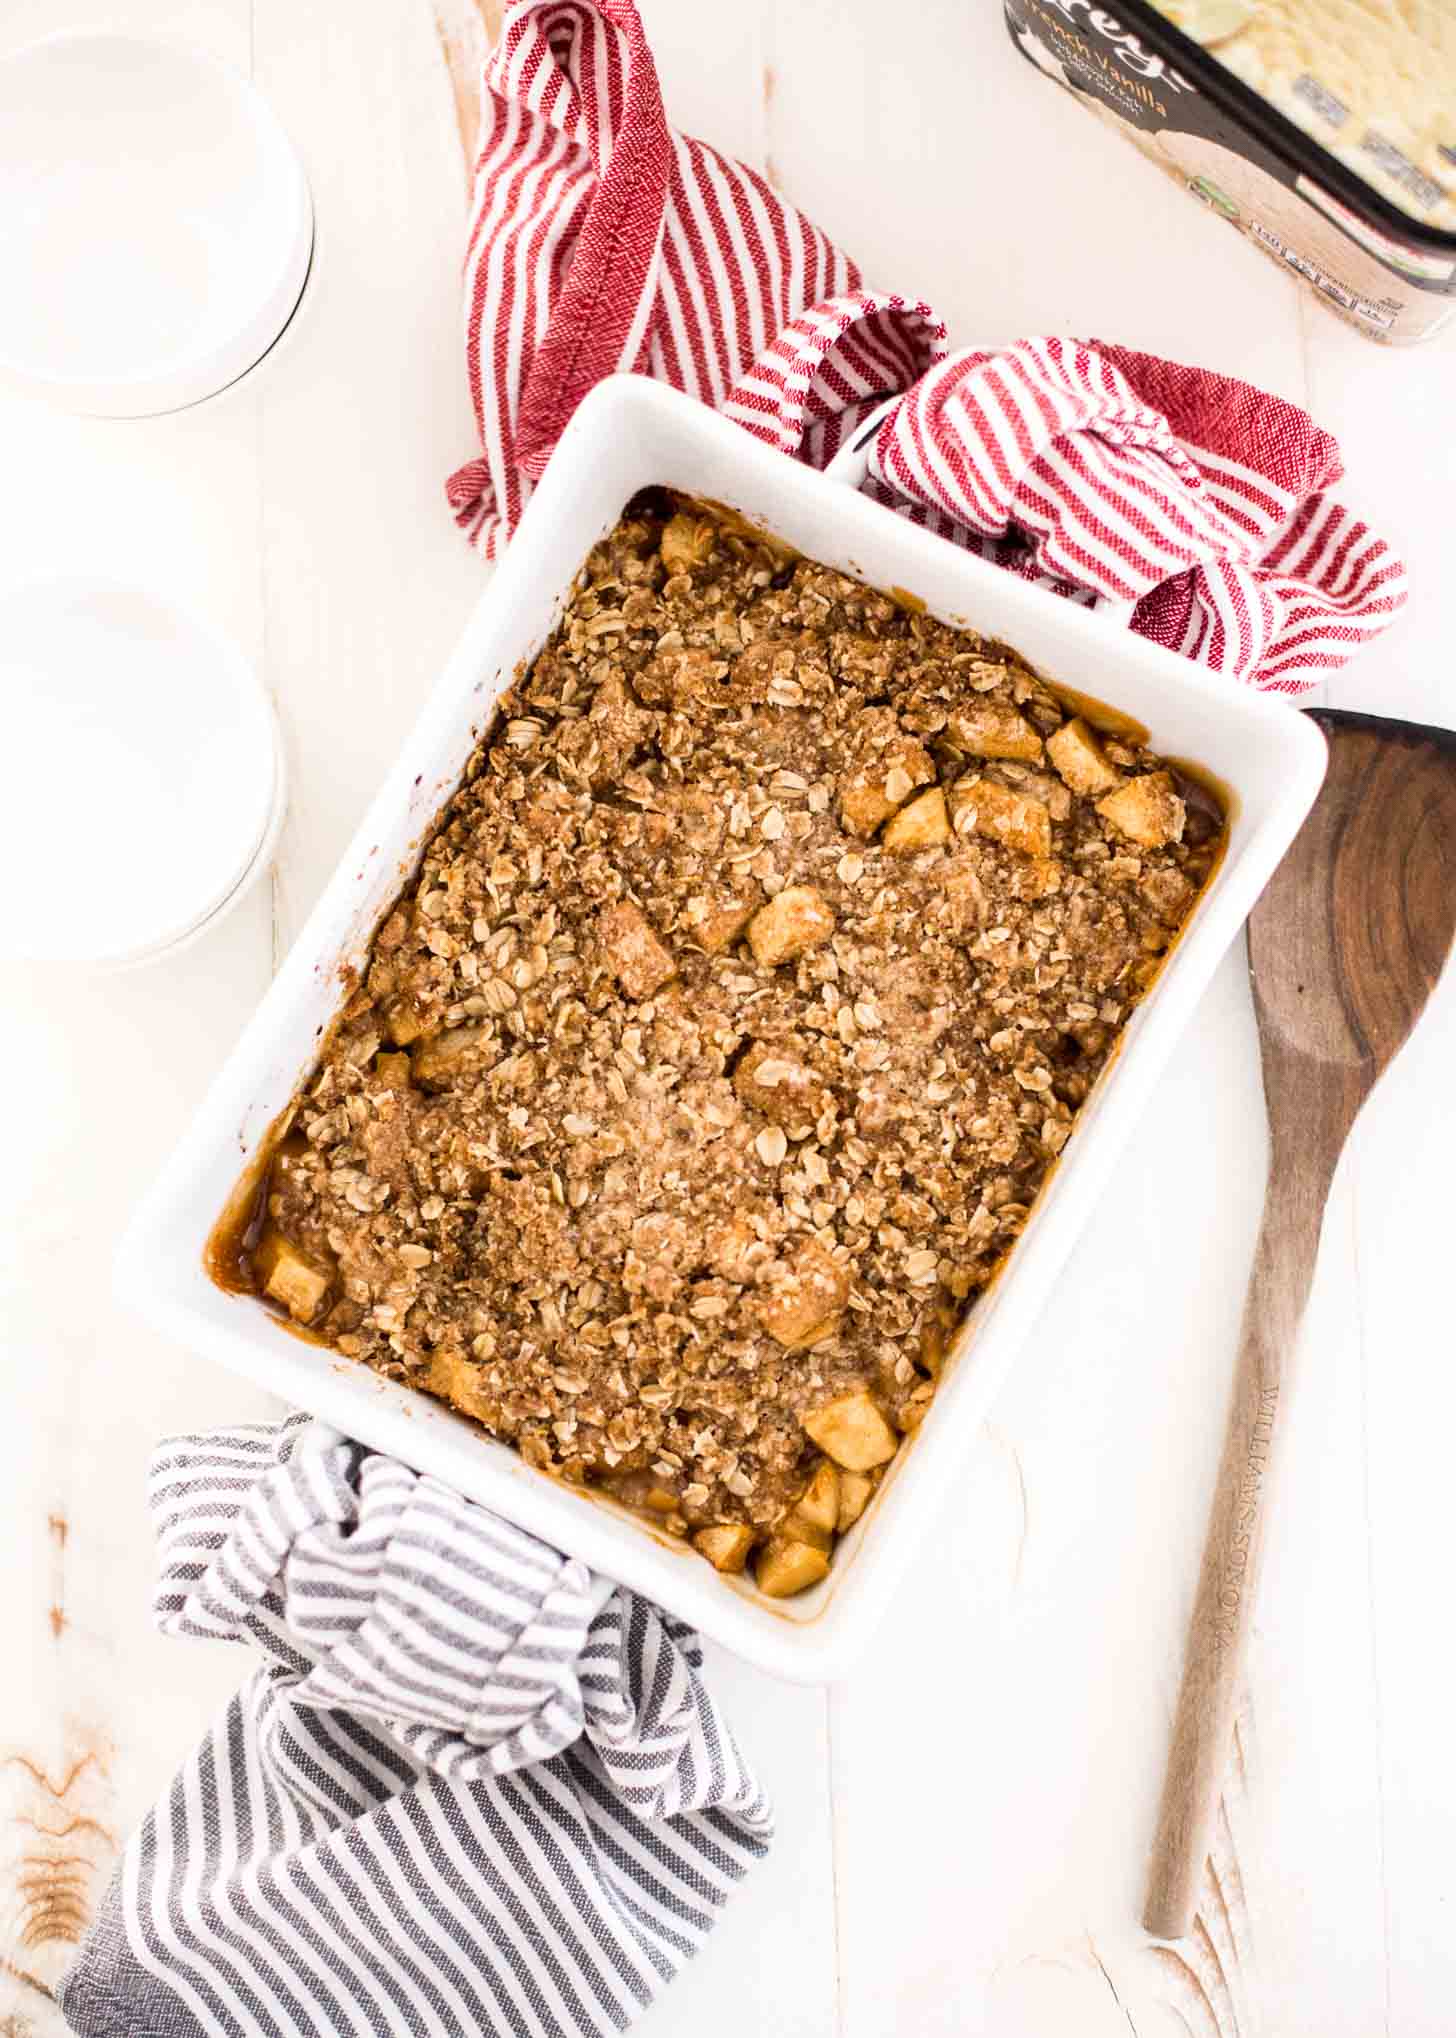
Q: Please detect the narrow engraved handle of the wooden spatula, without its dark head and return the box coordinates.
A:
[1142,1137,1340,1938]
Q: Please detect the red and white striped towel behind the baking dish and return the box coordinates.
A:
[449,0,1407,693]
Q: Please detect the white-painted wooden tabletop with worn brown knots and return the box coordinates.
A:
[0,0,1456,2038]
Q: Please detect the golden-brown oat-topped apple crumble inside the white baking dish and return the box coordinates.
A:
[215,495,1224,1594]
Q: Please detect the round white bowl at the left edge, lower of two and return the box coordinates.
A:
[0,579,281,964]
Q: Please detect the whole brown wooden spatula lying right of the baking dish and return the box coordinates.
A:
[1144,709,1456,1938]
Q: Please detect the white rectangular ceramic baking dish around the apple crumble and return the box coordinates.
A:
[118,377,1323,1681]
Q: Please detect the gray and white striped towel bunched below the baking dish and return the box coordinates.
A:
[61,1416,773,2038]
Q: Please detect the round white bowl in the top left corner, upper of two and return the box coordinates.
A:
[0,31,314,418]
